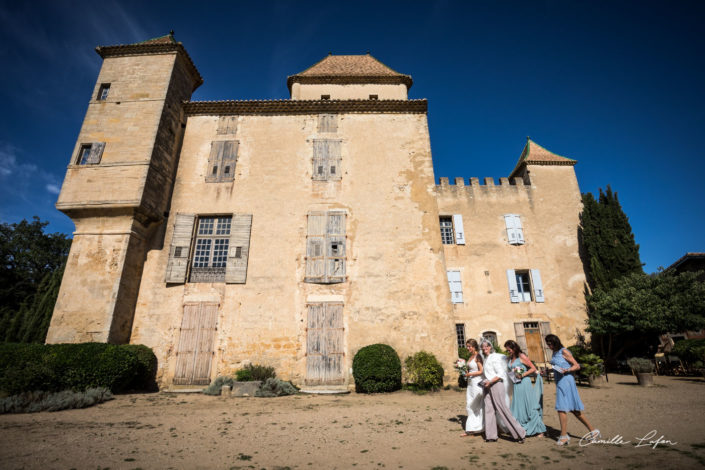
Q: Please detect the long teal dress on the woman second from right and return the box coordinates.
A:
[509,357,546,436]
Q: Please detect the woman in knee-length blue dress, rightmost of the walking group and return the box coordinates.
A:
[546,335,600,446]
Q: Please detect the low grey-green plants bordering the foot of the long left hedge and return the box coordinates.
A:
[0,388,113,414]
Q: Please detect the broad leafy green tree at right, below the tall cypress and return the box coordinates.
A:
[587,272,705,360]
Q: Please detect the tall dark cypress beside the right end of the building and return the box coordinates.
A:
[580,186,643,291]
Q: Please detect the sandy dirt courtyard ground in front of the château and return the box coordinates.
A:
[0,375,705,470]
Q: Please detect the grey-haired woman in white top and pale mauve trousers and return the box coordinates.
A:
[480,339,526,443]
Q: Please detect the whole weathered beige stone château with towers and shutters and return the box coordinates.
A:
[47,36,585,388]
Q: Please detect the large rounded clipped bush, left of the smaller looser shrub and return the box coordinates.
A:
[353,344,401,393]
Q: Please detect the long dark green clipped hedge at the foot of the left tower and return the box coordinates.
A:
[0,343,157,396]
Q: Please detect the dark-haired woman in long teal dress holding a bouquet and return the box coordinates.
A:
[504,340,546,437]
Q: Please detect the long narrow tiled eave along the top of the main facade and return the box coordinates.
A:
[184,100,428,115]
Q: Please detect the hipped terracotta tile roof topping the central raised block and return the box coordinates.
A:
[287,54,413,90]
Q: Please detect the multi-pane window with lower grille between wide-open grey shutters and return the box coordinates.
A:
[189,216,232,282]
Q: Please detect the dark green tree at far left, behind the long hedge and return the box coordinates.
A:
[0,216,71,342]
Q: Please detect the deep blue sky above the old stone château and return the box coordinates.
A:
[0,0,705,272]
